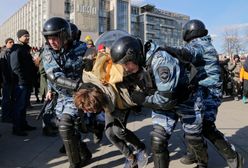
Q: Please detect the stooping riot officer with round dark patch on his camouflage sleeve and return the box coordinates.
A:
[111,36,207,168]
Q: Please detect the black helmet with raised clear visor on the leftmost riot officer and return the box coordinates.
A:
[42,17,71,44]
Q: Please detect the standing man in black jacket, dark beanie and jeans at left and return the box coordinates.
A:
[10,29,36,136]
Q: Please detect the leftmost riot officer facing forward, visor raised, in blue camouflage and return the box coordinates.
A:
[42,17,92,168]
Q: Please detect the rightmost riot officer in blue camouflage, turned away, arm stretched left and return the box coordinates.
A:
[165,20,244,168]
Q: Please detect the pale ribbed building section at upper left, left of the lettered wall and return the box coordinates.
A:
[0,0,65,47]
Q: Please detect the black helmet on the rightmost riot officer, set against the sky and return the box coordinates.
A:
[183,20,208,42]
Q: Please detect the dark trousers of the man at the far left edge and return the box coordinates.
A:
[2,83,12,120]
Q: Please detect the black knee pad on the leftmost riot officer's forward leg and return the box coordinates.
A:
[59,114,75,140]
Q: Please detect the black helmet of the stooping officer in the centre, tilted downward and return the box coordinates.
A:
[110,36,145,66]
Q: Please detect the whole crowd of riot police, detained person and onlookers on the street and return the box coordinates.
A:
[0,17,244,168]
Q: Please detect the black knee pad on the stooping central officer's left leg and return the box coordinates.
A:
[151,125,170,153]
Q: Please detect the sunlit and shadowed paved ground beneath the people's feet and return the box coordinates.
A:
[0,96,248,168]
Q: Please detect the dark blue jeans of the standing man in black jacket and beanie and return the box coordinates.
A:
[13,85,30,129]
